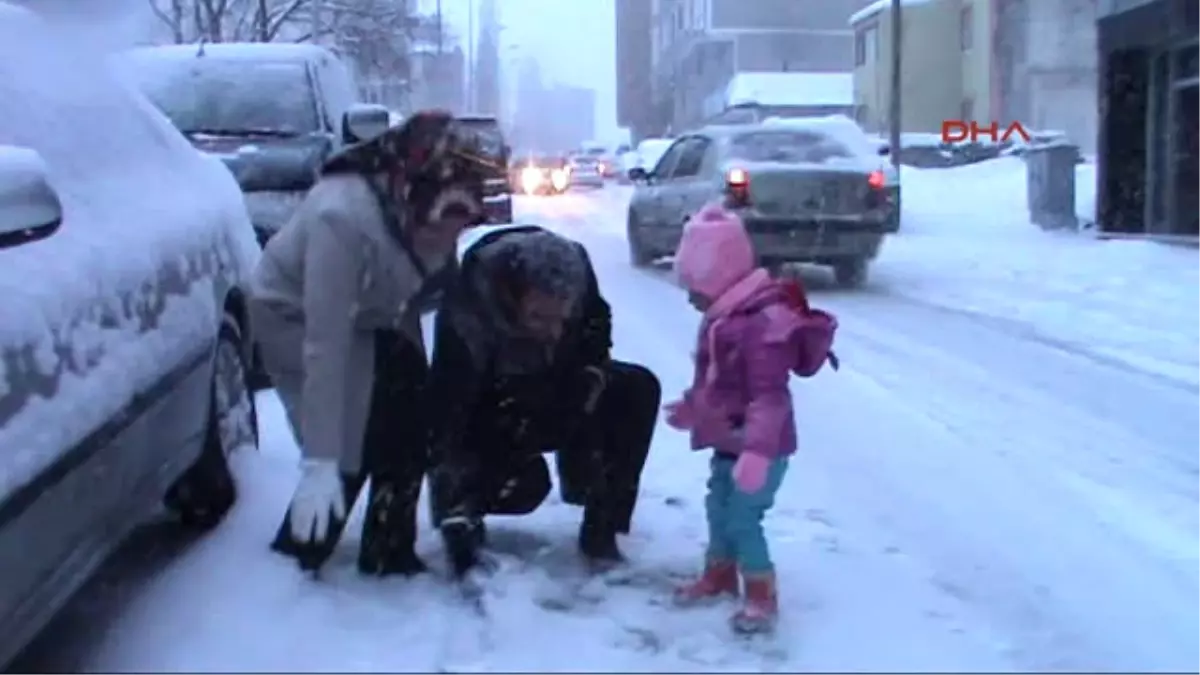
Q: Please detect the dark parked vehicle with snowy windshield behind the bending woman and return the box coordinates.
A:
[122,43,394,244]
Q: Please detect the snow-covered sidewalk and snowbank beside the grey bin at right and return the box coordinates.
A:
[875,160,1200,386]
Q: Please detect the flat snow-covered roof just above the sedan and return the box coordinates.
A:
[725,72,854,106]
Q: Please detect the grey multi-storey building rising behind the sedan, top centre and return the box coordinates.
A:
[652,0,864,131]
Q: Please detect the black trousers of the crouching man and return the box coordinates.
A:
[470,362,662,537]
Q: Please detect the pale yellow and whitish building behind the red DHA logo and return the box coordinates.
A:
[851,0,1097,146]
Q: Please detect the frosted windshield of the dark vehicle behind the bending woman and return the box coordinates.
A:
[133,56,322,136]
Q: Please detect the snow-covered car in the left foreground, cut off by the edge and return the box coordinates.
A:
[0,2,260,665]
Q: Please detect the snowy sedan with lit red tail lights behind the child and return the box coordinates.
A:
[628,118,895,286]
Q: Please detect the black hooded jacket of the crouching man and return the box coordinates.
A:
[426,227,612,520]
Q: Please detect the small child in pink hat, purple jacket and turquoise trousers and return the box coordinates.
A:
[665,205,836,633]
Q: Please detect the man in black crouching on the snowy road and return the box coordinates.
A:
[428,227,661,571]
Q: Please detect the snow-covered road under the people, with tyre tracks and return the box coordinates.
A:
[18,190,1200,671]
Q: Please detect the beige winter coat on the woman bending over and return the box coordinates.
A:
[250,173,438,473]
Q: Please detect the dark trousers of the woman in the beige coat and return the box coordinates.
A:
[271,330,428,574]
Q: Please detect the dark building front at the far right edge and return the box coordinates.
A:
[1097,0,1200,238]
